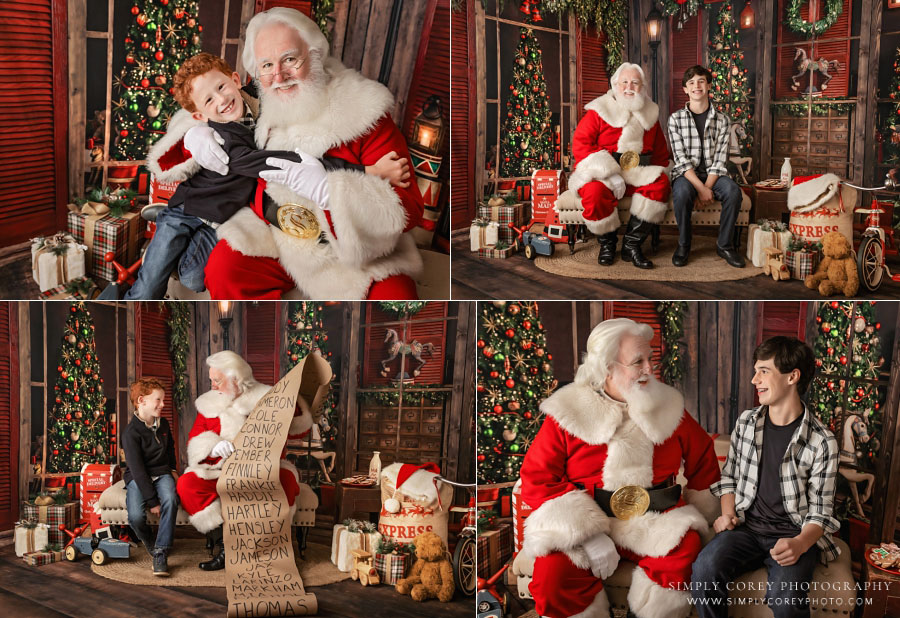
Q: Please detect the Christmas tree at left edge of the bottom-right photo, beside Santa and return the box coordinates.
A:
[477,301,557,483]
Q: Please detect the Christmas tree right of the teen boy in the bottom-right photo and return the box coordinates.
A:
[808,301,885,469]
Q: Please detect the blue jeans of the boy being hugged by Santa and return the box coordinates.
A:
[125,206,219,300]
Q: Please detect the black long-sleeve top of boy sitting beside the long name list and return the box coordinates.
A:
[122,414,178,508]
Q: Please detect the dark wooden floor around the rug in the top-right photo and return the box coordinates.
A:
[450,229,900,300]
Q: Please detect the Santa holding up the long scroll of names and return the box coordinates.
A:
[176,350,313,571]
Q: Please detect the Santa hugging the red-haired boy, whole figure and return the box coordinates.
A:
[148,7,423,300]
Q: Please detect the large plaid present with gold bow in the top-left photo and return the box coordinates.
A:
[68,211,146,281]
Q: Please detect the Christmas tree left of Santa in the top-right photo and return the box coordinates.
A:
[500,28,553,178]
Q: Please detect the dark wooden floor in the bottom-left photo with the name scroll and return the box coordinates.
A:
[0,529,475,618]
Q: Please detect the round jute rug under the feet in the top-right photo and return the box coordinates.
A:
[534,236,763,281]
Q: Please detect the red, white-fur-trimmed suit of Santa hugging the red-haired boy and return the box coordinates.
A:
[147,58,424,300]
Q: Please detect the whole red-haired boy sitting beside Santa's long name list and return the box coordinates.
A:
[122,378,178,577]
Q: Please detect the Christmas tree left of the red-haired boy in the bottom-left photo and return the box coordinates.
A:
[47,303,111,473]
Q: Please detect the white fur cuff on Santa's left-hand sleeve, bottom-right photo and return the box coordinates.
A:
[522,490,610,568]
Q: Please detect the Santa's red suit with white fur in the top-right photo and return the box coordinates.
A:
[560,90,671,235]
